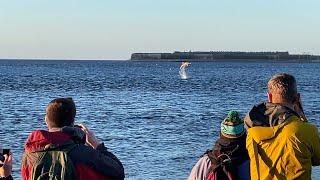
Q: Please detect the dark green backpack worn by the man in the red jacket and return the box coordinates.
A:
[30,142,77,180]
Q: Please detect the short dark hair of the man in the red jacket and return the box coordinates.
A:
[46,98,76,127]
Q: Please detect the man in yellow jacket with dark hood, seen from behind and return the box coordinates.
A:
[245,73,320,179]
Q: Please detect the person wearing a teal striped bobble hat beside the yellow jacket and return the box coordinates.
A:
[188,111,250,180]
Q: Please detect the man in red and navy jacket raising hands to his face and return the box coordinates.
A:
[21,98,125,180]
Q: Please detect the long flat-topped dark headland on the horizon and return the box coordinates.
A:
[130,51,320,62]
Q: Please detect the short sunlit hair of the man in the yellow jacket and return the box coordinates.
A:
[268,73,298,103]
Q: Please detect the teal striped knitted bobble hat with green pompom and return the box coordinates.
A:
[221,111,245,138]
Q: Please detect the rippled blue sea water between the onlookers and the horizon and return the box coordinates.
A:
[0,60,320,180]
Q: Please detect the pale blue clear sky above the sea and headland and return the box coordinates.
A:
[0,0,320,60]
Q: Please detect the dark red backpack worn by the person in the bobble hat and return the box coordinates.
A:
[205,145,238,180]
